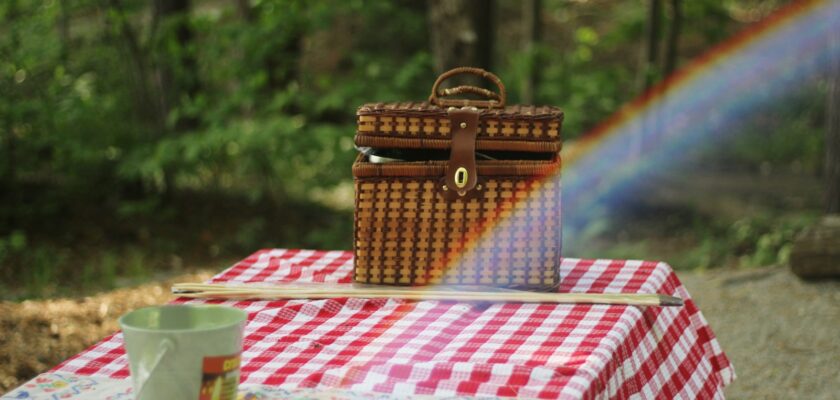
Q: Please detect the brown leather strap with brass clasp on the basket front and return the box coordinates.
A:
[442,107,478,199]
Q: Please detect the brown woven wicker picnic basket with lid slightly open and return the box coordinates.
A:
[353,67,563,291]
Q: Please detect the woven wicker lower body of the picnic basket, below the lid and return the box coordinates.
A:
[355,172,560,290]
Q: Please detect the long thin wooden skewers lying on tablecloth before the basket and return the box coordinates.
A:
[172,283,683,306]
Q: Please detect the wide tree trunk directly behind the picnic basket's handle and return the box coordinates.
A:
[429,0,495,76]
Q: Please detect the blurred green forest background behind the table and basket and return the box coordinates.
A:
[0,0,828,300]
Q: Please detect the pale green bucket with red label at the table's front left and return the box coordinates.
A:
[120,305,248,400]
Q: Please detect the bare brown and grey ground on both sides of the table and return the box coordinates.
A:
[0,268,840,399]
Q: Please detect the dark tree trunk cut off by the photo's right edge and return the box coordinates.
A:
[825,27,840,214]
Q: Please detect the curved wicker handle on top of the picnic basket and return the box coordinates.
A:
[429,67,507,108]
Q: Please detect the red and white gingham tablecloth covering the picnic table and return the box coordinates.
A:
[53,249,734,398]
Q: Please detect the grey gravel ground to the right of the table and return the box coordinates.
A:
[678,268,840,399]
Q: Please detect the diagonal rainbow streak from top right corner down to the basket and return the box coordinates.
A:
[464,1,840,268]
